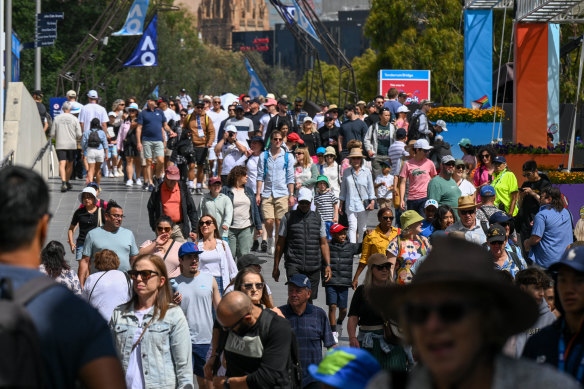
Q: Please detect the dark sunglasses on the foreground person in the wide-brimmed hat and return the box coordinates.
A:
[404,301,476,325]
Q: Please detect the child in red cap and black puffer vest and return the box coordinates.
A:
[322,224,363,343]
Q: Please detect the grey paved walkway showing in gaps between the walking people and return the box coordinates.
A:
[47,178,377,345]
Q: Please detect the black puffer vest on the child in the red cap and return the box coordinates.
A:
[322,240,363,286]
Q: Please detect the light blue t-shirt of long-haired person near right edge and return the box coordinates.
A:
[528,205,574,269]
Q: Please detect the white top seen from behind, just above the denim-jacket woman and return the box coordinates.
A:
[81,270,132,322]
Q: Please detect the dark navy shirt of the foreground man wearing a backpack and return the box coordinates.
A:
[0,264,117,389]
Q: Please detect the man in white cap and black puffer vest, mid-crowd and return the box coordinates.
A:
[272,188,332,301]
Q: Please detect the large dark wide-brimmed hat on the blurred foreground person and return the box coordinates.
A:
[366,237,539,337]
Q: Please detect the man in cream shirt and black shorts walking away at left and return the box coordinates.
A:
[51,101,83,192]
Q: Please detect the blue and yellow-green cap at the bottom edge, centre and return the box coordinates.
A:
[308,347,381,389]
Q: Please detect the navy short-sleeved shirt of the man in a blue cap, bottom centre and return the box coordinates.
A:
[279,304,335,387]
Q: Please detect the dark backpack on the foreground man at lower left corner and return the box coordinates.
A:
[0,277,57,388]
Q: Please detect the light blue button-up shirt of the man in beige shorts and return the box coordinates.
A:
[257,148,294,199]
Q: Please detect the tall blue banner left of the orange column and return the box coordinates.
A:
[464,9,493,109]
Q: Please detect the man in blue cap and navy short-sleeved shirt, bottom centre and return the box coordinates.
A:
[279,274,336,389]
